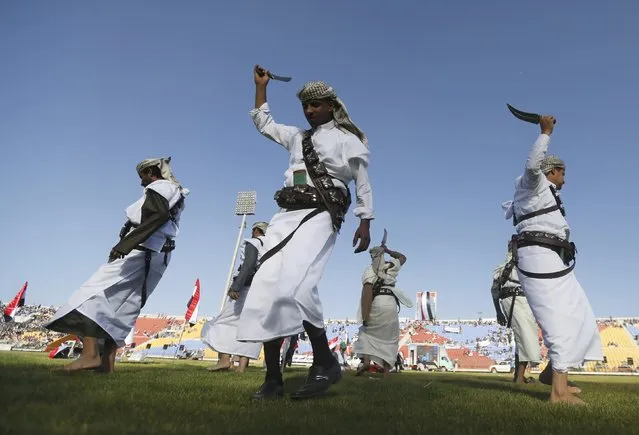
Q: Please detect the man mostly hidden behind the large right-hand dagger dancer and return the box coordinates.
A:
[490,250,541,384]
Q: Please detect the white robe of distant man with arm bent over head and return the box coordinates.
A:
[353,258,401,366]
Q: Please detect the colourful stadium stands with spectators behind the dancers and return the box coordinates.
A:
[0,305,639,372]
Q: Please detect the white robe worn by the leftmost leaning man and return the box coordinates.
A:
[43,180,179,347]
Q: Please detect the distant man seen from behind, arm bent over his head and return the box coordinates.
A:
[353,246,412,377]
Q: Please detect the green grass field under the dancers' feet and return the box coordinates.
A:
[0,352,639,435]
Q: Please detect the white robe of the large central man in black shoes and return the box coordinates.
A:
[237,103,374,342]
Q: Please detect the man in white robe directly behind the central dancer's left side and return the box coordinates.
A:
[201,222,268,373]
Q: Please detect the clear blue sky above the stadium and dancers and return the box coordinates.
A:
[0,1,639,318]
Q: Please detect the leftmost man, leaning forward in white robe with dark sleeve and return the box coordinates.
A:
[44,157,189,373]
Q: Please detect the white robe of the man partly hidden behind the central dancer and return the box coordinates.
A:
[201,237,265,359]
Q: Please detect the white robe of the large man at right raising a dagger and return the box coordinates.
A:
[513,134,603,372]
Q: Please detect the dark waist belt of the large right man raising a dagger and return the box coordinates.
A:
[512,231,577,279]
